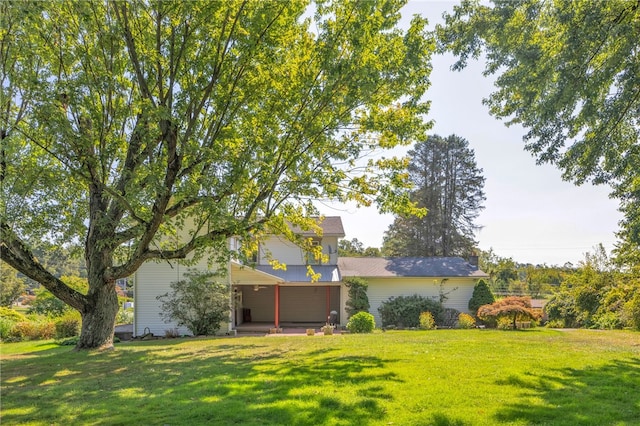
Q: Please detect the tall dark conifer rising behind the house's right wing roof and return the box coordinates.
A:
[383,135,485,256]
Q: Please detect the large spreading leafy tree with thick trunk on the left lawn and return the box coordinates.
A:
[0,0,435,348]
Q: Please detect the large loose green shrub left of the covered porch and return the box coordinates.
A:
[157,271,230,336]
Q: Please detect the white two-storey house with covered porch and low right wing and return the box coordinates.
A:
[134,216,487,336]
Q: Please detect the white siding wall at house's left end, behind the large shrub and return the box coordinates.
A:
[133,259,229,336]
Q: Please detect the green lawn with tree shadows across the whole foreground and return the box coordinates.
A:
[1,329,640,425]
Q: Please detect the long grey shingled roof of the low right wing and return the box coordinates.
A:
[338,257,488,278]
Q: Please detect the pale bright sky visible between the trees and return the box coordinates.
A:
[320,0,622,265]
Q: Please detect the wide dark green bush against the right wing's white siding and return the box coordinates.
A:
[378,294,444,328]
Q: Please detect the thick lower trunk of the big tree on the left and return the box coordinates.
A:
[76,282,120,349]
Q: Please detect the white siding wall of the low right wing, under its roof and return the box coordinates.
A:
[366,277,475,327]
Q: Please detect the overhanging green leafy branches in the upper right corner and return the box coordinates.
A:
[438,0,640,265]
